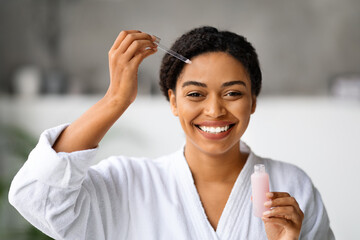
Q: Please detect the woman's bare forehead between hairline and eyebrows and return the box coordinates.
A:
[176,52,250,85]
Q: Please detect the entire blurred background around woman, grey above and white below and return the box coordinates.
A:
[0,0,360,239]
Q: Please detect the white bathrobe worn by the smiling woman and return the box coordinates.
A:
[9,125,334,240]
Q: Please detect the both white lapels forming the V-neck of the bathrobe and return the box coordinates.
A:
[174,142,256,240]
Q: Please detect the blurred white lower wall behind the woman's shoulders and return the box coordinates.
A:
[0,97,360,239]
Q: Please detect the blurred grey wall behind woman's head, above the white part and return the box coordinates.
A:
[0,0,360,94]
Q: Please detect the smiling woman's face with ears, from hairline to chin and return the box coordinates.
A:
[169,52,256,155]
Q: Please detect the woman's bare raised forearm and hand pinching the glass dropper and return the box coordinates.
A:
[53,31,156,152]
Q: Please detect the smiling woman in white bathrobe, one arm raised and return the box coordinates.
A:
[9,27,334,240]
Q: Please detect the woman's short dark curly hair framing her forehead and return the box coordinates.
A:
[159,26,262,100]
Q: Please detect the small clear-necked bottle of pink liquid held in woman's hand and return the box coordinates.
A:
[251,164,269,217]
